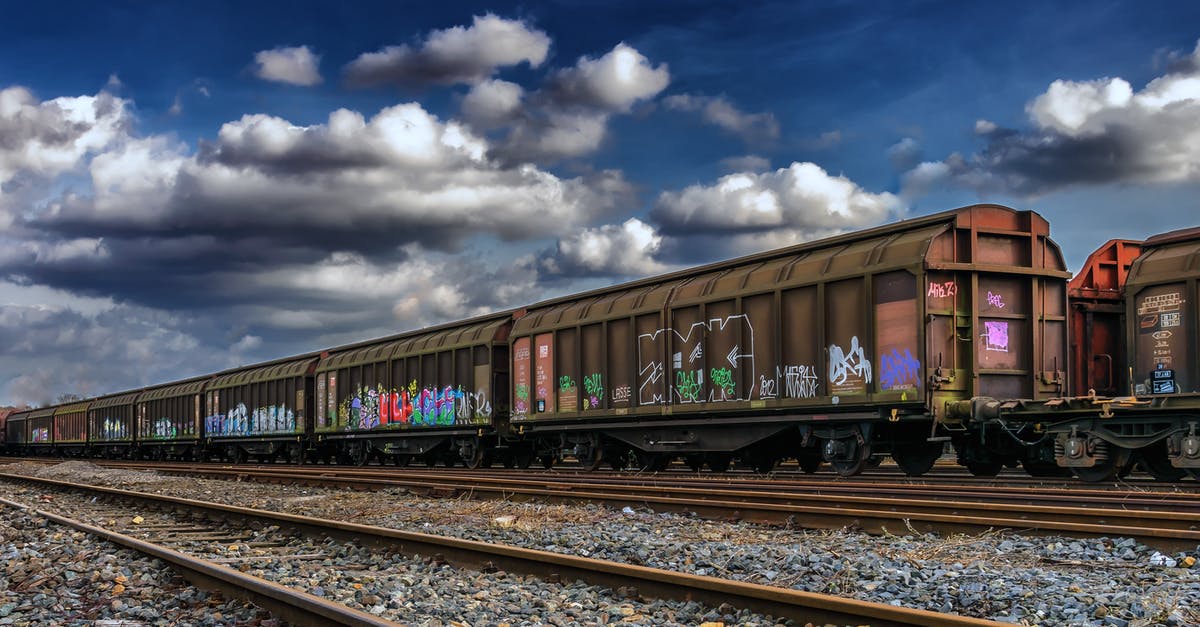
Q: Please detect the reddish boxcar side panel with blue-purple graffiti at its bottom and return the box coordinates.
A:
[874,270,923,393]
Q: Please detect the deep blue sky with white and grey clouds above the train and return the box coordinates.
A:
[0,1,1200,404]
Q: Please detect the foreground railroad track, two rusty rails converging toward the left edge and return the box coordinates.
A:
[0,474,1001,627]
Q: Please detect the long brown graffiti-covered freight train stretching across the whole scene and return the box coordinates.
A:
[5,204,1200,480]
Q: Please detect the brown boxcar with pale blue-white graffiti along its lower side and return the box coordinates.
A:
[206,354,319,461]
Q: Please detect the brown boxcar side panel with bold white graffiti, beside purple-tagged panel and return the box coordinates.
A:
[824,279,874,399]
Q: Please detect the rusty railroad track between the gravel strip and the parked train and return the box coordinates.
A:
[4,461,1200,550]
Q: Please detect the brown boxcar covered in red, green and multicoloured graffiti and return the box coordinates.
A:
[314,311,512,467]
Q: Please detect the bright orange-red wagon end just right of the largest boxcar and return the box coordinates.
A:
[1067,239,1141,396]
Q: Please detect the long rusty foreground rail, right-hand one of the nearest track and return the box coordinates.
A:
[0,473,1003,627]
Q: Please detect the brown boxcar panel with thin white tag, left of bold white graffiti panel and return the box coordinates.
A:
[782,286,826,400]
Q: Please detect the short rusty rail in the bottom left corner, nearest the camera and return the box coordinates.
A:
[0,492,400,627]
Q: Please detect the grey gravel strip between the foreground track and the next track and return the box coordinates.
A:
[0,462,1200,627]
